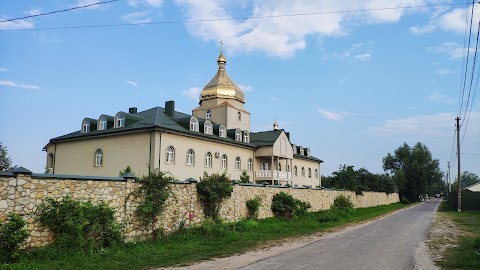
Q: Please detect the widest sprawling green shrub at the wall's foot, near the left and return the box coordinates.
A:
[36,196,122,253]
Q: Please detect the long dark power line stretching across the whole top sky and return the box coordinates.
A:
[0,0,466,32]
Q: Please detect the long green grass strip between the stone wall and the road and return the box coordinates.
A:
[0,203,406,270]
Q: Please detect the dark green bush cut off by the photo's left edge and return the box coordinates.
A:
[0,213,28,263]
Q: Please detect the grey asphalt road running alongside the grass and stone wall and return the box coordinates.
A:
[238,200,440,270]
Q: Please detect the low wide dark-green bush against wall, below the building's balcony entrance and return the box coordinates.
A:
[271,192,311,218]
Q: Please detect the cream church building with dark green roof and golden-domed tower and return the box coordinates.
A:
[44,52,323,187]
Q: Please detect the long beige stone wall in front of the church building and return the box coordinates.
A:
[0,172,399,247]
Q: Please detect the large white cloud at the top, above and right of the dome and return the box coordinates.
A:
[175,0,425,57]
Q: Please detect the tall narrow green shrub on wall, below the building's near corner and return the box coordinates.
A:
[132,170,175,239]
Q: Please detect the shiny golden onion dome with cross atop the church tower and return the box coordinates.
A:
[200,51,245,103]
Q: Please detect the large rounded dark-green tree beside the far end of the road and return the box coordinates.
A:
[383,142,445,201]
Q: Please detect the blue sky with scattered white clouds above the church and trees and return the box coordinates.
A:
[0,0,480,179]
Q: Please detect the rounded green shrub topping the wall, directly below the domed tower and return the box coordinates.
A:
[197,172,233,221]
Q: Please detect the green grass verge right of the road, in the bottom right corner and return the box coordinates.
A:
[437,202,480,269]
